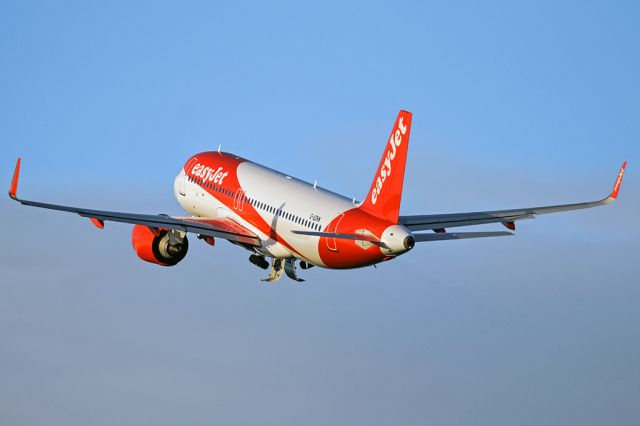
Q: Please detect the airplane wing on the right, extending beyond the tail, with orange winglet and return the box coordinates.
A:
[398,161,627,232]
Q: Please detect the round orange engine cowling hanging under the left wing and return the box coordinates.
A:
[131,225,189,266]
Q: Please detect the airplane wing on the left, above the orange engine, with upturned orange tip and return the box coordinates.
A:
[9,158,261,246]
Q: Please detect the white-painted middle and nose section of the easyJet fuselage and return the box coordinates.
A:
[174,161,356,266]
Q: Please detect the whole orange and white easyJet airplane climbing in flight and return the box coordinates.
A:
[9,111,627,282]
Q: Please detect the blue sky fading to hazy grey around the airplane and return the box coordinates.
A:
[0,1,640,426]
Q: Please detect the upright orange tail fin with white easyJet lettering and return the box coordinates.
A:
[360,111,411,223]
